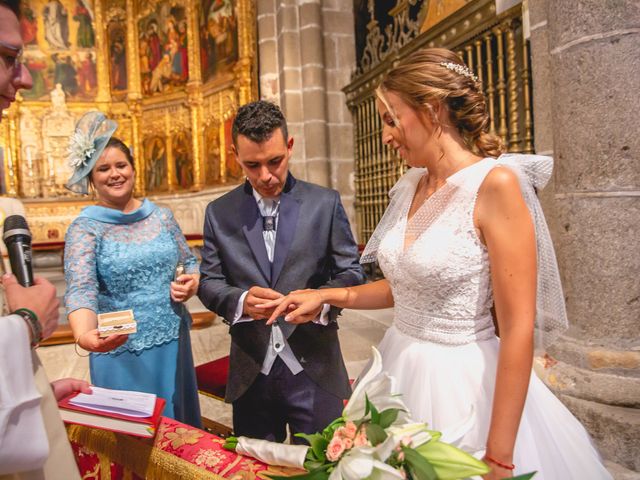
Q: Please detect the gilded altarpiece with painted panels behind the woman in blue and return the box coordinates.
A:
[0,0,257,242]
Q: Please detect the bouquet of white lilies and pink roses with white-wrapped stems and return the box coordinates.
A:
[224,348,533,480]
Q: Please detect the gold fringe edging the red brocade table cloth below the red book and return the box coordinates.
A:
[67,425,224,480]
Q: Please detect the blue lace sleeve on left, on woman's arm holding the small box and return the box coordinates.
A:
[64,218,98,315]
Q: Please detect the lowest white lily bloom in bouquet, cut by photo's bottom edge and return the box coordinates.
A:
[329,447,403,480]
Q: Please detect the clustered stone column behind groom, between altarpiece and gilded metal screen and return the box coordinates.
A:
[257,0,355,218]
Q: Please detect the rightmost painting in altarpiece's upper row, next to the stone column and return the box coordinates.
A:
[199,0,238,82]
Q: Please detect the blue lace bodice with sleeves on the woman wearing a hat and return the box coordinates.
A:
[64,201,198,354]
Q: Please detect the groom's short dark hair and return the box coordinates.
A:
[231,100,289,148]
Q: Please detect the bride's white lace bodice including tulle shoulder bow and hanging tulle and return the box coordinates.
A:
[372,154,568,348]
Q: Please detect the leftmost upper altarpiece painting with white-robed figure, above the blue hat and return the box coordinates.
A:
[20,0,98,101]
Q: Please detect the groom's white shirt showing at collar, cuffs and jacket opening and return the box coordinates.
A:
[231,190,331,375]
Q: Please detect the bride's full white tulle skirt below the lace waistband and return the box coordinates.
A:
[379,326,612,480]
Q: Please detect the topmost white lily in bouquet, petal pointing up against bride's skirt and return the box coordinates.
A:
[342,347,407,424]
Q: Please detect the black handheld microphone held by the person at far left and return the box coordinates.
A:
[2,215,33,287]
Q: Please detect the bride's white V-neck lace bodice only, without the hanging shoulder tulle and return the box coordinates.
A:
[378,161,495,345]
